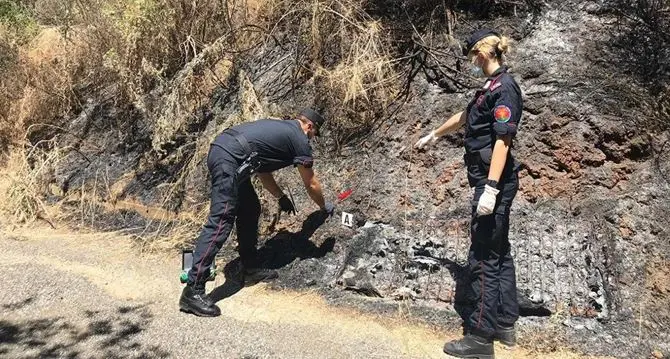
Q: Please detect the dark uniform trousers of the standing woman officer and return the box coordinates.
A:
[463,159,519,338]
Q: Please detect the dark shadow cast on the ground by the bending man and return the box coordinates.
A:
[209,211,335,302]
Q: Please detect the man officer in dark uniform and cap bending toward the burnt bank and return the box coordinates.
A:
[179,109,334,316]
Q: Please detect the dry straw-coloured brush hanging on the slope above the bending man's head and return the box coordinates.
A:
[266,0,402,143]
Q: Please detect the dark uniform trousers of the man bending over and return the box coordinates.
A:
[188,145,261,284]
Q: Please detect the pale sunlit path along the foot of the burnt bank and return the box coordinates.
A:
[0,230,608,359]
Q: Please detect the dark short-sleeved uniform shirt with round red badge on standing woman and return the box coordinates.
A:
[465,66,523,183]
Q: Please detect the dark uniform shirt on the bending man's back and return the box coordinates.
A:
[212,120,314,173]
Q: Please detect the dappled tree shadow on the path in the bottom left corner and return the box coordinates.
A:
[0,298,170,358]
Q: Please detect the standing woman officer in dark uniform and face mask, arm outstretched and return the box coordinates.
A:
[416,30,523,359]
